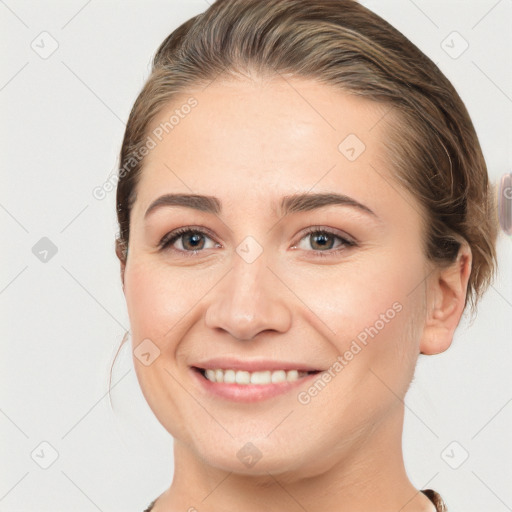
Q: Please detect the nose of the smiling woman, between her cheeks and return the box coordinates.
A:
[205,255,292,341]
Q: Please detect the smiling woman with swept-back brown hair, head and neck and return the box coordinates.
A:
[116,0,497,512]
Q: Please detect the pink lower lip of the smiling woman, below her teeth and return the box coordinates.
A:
[191,368,319,402]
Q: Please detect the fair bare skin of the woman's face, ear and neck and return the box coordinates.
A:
[121,78,471,512]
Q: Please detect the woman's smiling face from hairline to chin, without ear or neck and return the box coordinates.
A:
[124,78,427,474]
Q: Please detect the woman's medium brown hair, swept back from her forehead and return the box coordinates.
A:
[116,0,498,318]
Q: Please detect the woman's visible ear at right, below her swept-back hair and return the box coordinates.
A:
[420,242,472,355]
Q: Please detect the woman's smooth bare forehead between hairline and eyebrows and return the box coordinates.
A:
[136,78,408,218]
